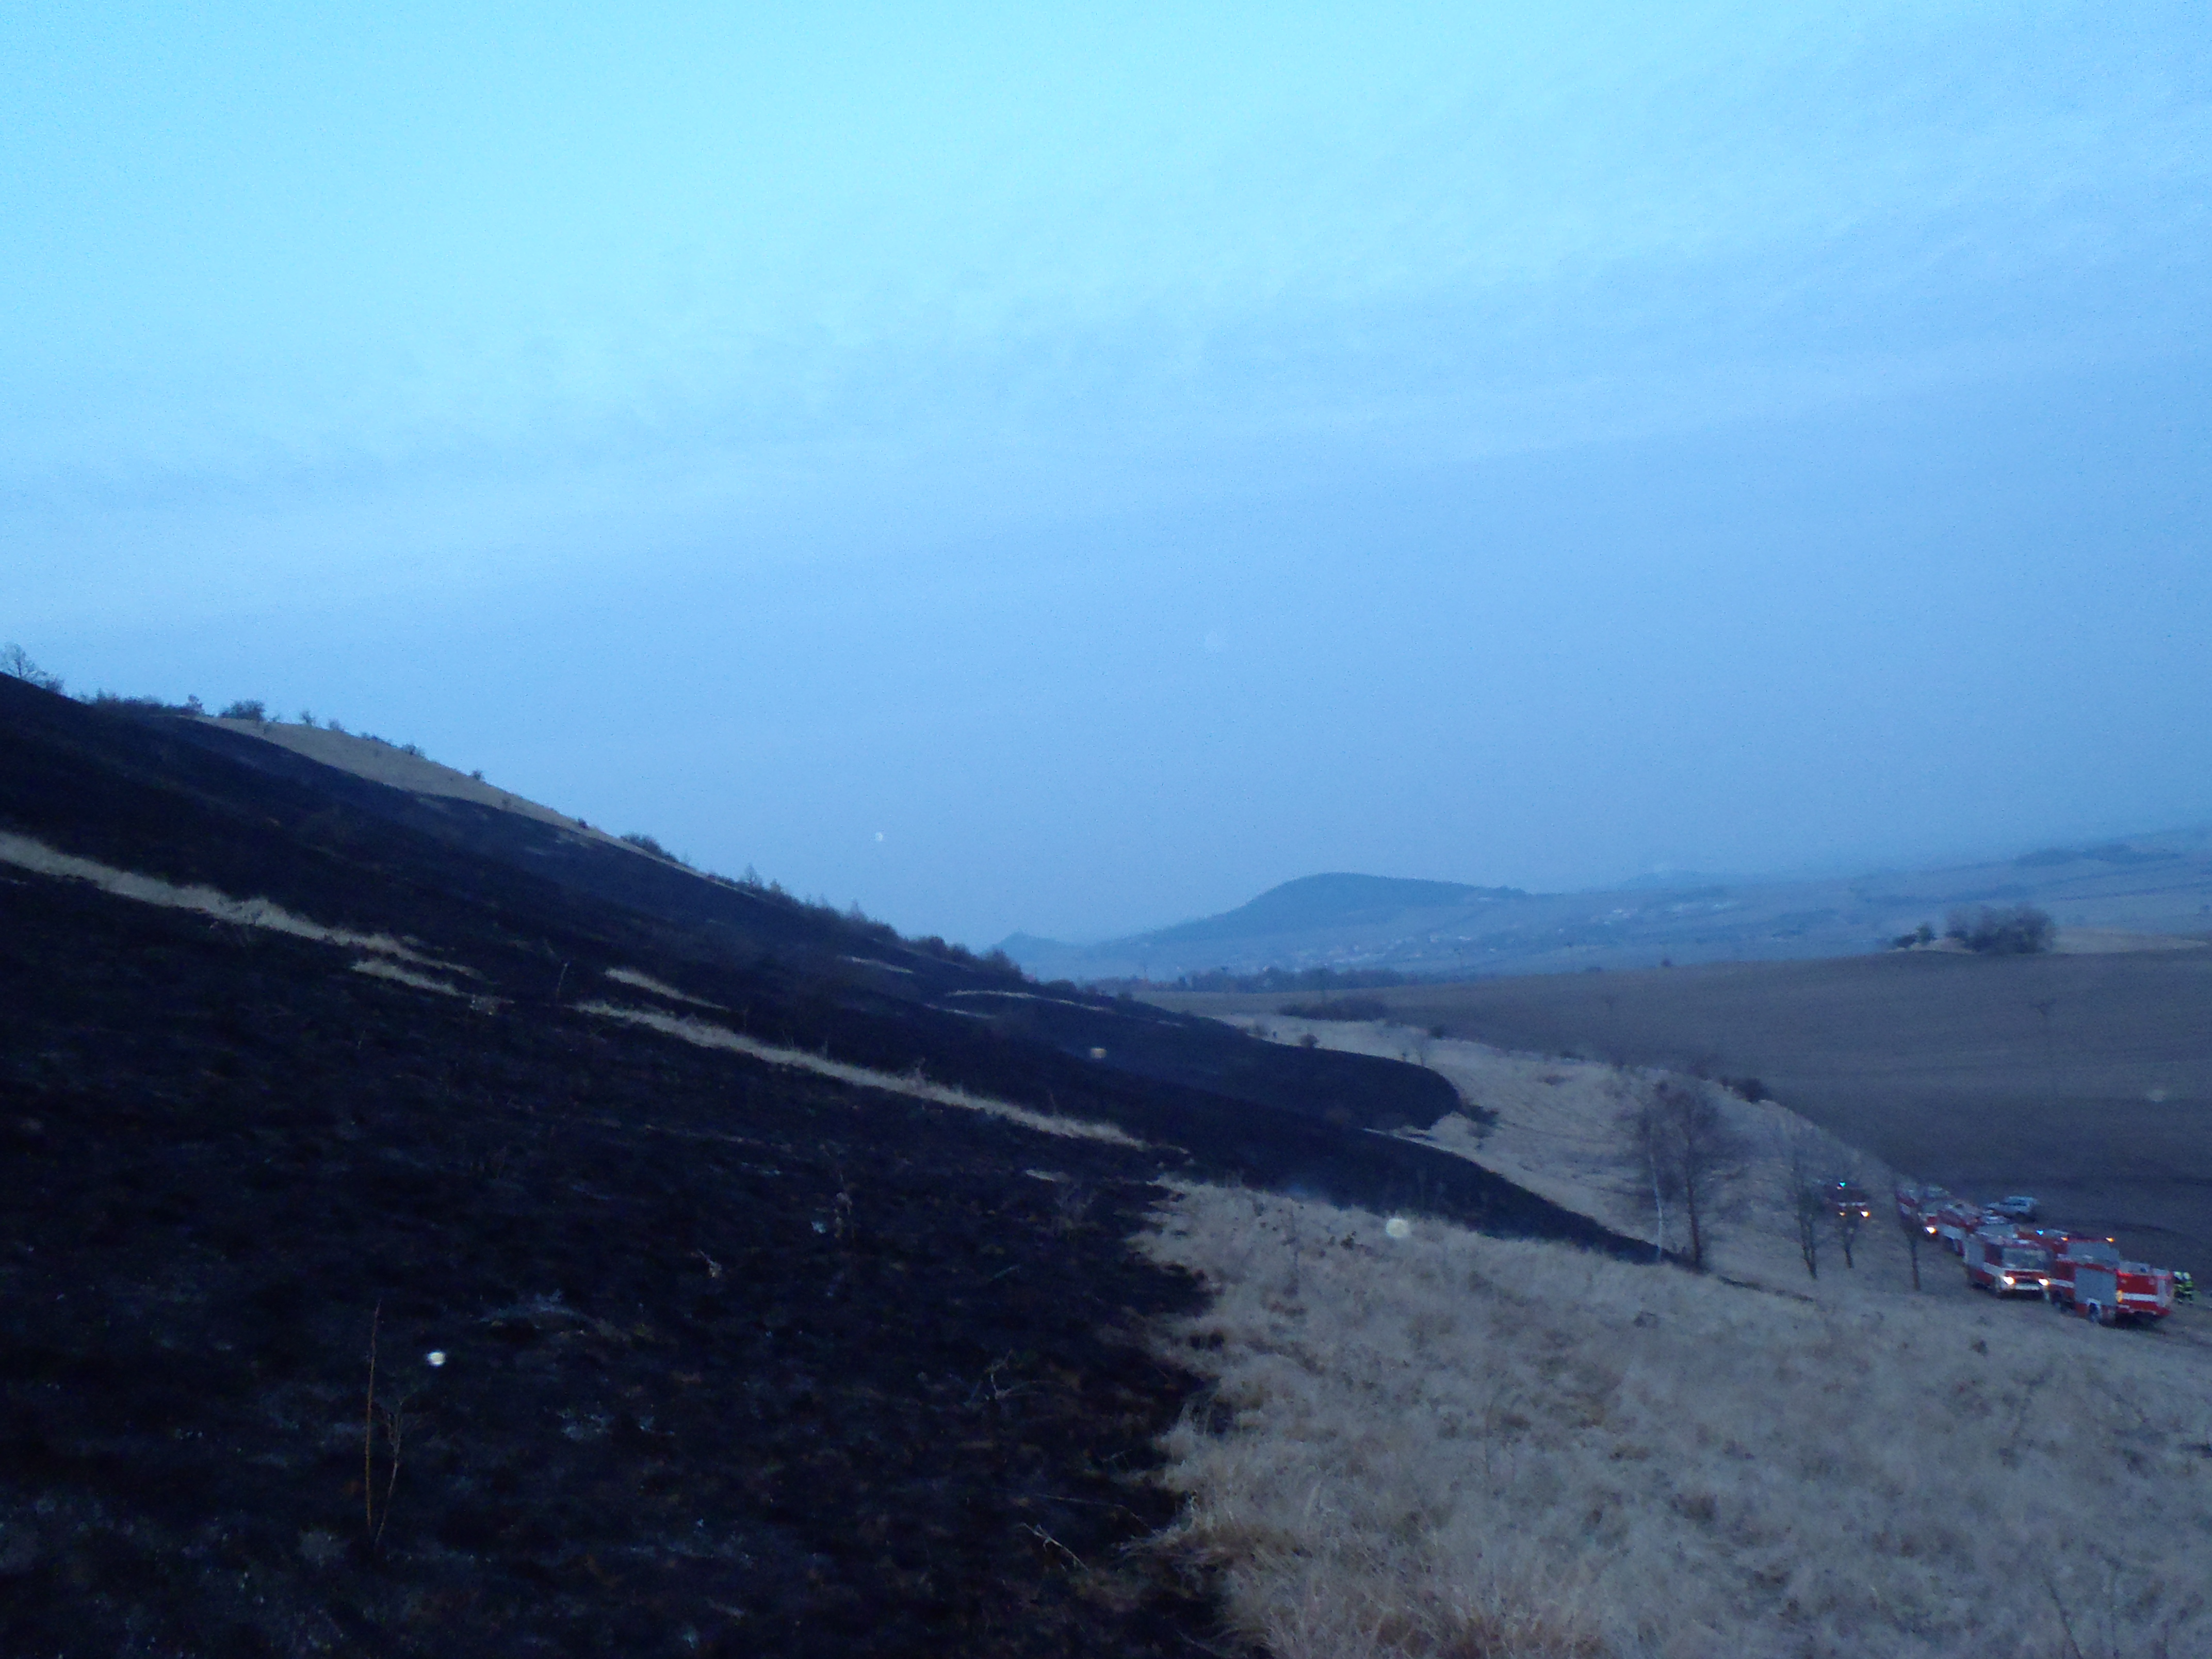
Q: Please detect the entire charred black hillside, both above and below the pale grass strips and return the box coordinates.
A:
[0,688,1646,1654]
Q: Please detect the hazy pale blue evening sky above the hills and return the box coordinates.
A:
[0,0,2212,945]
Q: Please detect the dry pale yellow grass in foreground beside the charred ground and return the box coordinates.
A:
[1144,1188,2212,1659]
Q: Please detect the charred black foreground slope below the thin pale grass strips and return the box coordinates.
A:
[0,883,1212,1654]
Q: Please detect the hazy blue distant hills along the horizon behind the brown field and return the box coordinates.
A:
[1000,829,2212,982]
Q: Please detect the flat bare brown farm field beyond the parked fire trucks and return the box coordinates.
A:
[1150,951,2212,1276]
